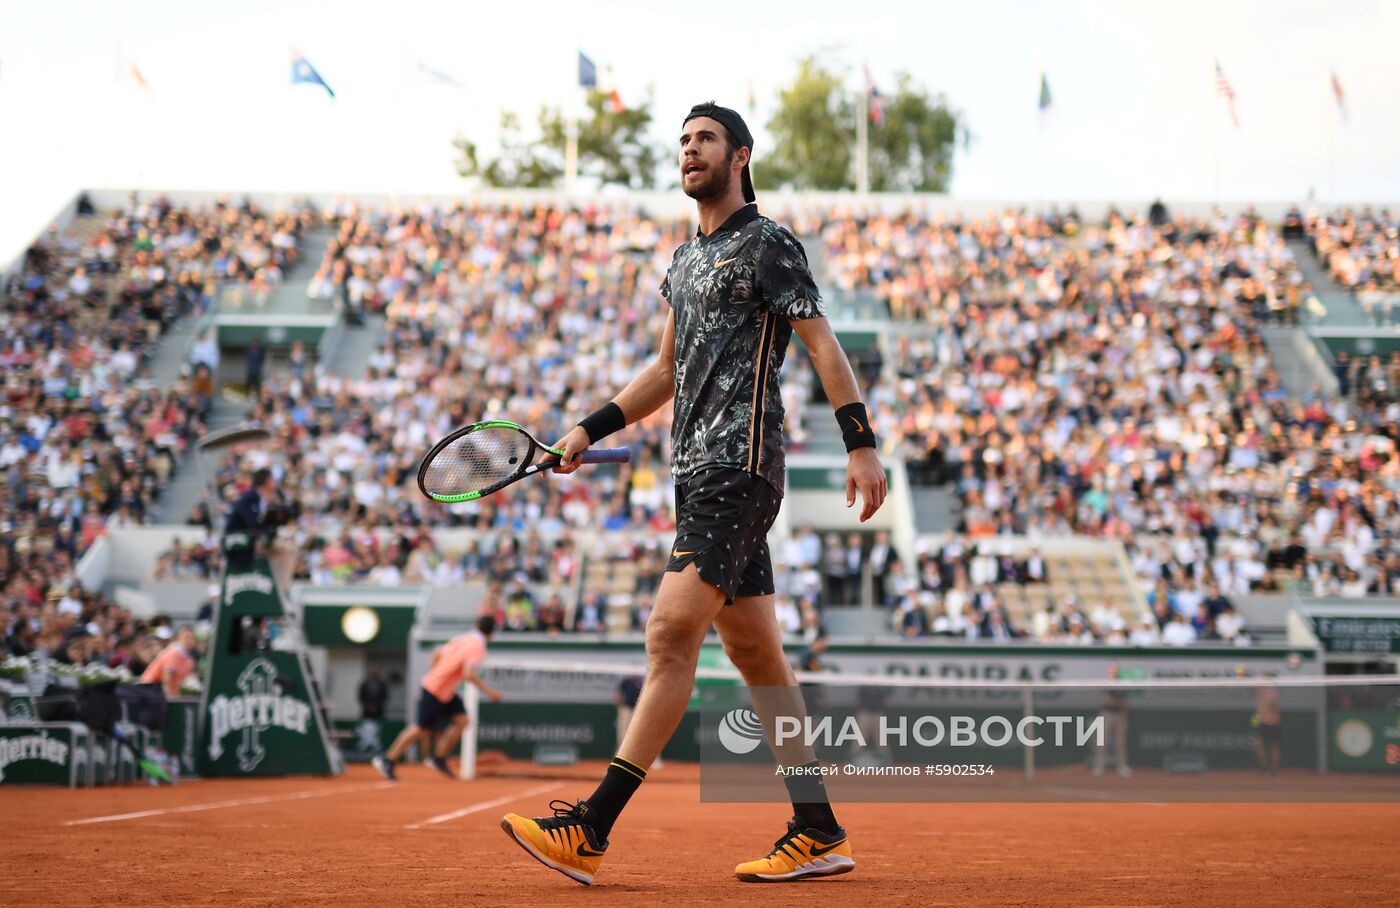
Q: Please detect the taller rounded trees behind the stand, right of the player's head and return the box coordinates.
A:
[753,56,967,192]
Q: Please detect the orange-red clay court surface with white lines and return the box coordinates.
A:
[10,764,1400,905]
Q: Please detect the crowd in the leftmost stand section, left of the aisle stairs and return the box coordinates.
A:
[0,197,314,667]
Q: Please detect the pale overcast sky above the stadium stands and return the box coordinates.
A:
[0,0,1400,263]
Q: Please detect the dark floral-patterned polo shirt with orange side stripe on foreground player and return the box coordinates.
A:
[661,203,826,495]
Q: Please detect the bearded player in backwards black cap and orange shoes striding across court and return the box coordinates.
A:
[501,102,886,886]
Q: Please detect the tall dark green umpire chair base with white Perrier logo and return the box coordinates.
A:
[199,560,343,775]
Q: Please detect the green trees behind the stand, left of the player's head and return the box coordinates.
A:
[452,88,661,189]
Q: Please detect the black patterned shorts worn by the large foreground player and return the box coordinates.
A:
[666,467,783,606]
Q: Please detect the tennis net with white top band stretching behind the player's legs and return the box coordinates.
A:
[463,658,1400,802]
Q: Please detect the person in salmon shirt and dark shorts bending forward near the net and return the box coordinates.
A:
[370,614,501,779]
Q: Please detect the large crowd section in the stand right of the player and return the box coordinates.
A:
[825,204,1400,637]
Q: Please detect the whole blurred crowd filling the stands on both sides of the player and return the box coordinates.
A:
[0,200,1400,651]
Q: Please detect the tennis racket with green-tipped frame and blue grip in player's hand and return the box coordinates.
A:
[419,420,631,504]
